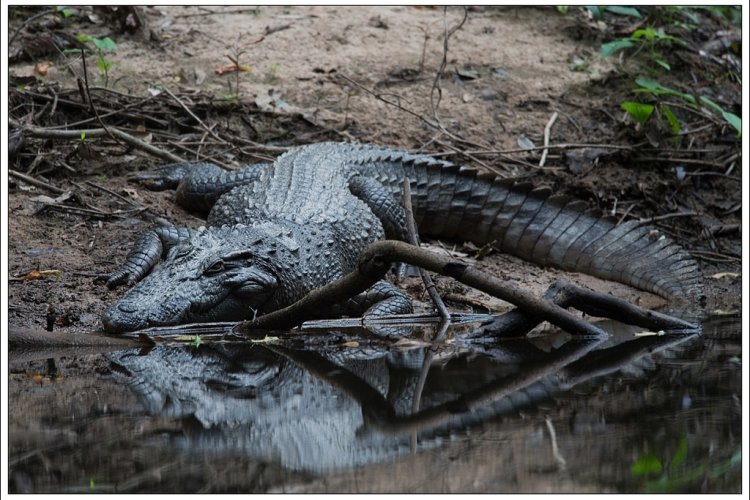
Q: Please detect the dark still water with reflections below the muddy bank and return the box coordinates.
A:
[9,318,742,493]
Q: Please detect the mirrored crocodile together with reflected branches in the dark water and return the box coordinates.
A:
[109,328,696,473]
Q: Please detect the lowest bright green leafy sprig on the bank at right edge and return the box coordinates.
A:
[620,78,742,137]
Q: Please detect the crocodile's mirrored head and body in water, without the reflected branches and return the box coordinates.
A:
[110,346,434,471]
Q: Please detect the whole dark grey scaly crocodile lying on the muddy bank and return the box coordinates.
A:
[102,142,702,333]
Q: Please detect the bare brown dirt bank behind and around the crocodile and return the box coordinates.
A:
[8,7,741,331]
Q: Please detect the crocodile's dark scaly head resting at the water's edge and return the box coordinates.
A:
[102,226,286,333]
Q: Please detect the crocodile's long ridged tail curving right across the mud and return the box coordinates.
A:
[362,150,703,300]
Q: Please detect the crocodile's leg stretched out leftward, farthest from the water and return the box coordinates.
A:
[131,162,269,215]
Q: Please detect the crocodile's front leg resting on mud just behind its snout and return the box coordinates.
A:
[107,227,194,289]
